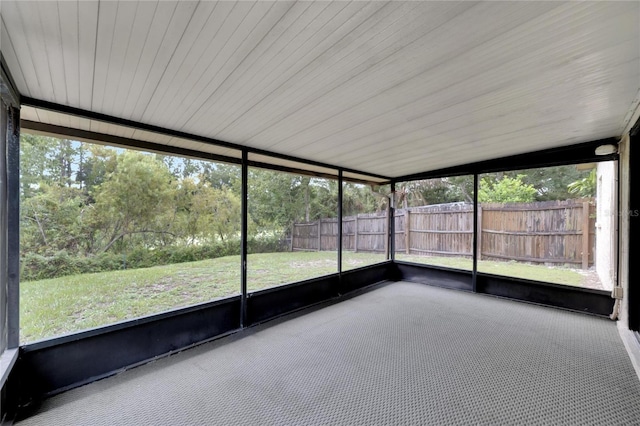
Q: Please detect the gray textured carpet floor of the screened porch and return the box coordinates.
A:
[18,282,640,426]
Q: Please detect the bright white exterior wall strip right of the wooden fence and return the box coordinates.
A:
[595,161,617,290]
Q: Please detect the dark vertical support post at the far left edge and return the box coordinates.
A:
[6,107,20,349]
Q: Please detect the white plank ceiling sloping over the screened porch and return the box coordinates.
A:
[0,0,640,177]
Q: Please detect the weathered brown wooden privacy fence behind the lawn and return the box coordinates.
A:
[291,199,595,269]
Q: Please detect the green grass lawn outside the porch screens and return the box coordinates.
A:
[20,252,583,343]
